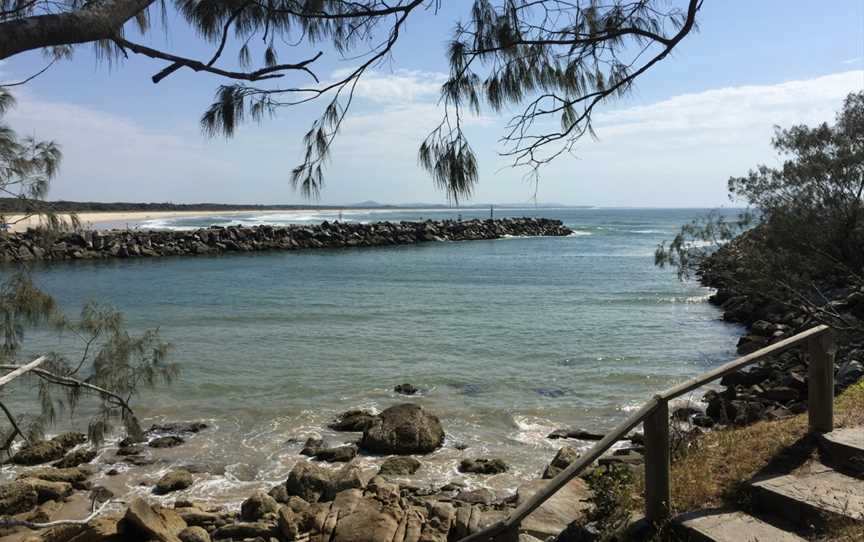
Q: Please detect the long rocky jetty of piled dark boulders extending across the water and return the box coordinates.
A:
[0,218,573,262]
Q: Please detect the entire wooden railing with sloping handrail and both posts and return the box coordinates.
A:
[460,325,834,542]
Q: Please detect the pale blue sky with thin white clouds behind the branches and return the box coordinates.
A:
[0,0,864,207]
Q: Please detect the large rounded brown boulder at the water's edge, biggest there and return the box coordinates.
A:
[360,403,444,455]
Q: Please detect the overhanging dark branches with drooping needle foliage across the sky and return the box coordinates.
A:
[0,0,703,203]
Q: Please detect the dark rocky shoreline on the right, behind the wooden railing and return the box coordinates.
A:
[676,236,864,428]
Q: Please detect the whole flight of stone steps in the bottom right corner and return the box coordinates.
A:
[674,427,864,542]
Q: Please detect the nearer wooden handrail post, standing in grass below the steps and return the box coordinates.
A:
[643,396,672,525]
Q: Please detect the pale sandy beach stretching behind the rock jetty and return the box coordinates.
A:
[7,209,324,232]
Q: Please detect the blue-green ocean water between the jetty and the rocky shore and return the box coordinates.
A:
[0,209,739,510]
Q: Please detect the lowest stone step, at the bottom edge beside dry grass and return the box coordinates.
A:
[674,509,805,542]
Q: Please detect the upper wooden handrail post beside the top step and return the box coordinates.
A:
[807,332,834,433]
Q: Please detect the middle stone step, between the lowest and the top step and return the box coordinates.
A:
[750,462,864,527]
